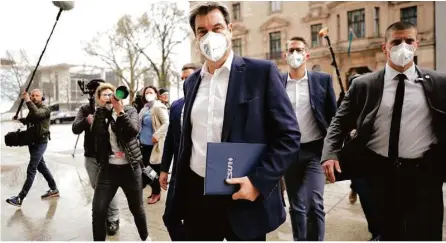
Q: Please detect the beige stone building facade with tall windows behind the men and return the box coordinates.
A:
[190,1,435,93]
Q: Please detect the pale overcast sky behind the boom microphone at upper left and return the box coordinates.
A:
[0,0,190,112]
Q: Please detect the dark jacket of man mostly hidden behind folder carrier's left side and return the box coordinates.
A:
[161,98,184,174]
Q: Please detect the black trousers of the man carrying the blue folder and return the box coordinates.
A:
[184,171,266,241]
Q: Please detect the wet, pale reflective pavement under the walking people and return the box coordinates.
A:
[0,122,446,241]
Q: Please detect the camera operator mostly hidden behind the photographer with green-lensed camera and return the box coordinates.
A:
[72,79,119,235]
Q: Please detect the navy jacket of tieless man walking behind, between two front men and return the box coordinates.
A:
[281,71,336,136]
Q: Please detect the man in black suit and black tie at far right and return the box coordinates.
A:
[321,22,446,241]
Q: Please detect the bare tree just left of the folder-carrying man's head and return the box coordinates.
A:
[138,2,189,88]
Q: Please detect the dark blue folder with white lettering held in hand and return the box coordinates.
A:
[204,143,267,195]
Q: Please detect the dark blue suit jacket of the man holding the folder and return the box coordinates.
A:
[169,56,300,239]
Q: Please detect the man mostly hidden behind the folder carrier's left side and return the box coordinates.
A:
[159,63,201,241]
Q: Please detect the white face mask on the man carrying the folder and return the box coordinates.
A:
[200,31,229,62]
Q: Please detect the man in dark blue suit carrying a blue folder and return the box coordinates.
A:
[172,2,300,241]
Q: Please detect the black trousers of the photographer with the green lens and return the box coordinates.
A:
[93,164,149,241]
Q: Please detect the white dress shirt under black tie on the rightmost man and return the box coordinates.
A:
[367,64,437,159]
